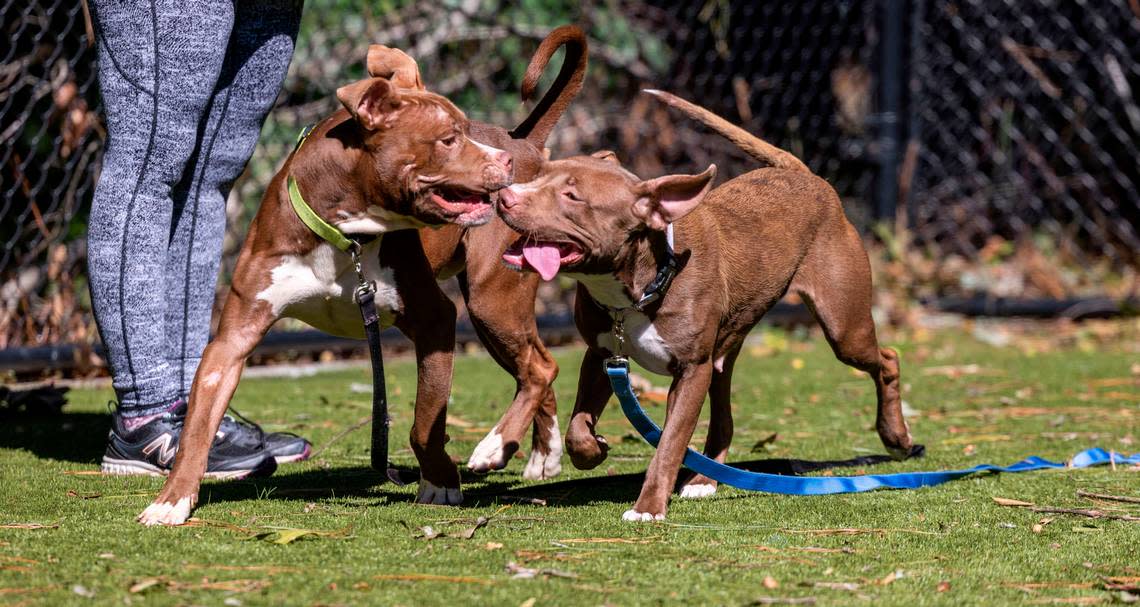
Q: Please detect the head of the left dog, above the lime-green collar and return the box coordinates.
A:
[336,78,512,226]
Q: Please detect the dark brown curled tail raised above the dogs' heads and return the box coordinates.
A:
[511,25,587,149]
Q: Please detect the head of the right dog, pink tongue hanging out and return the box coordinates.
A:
[498,152,716,281]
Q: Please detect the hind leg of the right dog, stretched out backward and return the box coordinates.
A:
[791,221,912,460]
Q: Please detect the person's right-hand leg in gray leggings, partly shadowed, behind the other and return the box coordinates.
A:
[164,0,301,398]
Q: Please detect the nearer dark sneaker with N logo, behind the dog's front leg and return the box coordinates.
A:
[103,405,277,479]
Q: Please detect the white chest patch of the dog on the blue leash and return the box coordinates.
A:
[565,273,673,375]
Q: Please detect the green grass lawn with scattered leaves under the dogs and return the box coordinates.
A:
[0,321,1140,606]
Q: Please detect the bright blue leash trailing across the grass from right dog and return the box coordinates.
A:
[605,356,1140,495]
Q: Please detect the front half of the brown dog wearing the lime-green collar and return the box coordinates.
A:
[139,73,512,525]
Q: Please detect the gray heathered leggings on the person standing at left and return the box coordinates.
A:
[88,0,301,418]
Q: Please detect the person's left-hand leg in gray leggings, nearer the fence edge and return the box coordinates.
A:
[88,0,234,430]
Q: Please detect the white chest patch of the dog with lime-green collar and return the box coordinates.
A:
[258,238,400,338]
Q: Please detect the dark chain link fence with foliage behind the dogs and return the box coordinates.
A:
[0,0,1140,369]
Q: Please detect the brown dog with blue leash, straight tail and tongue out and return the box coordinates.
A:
[499,94,911,520]
